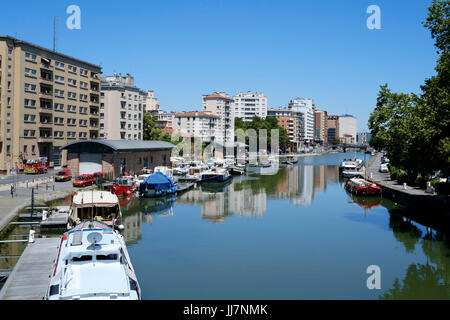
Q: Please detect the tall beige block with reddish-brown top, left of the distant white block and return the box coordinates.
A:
[202,92,234,142]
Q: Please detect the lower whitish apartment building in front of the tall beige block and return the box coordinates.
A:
[174,111,220,142]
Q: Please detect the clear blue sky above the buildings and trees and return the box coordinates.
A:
[0,0,437,131]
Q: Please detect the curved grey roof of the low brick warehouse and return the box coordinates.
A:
[61,140,175,153]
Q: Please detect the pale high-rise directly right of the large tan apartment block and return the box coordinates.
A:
[100,74,147,140]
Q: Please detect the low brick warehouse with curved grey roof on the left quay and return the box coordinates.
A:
[61,140,175,178]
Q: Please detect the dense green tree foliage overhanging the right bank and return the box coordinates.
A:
[368,0,450,181]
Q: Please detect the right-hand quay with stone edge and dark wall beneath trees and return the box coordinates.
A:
[367,153,450,232]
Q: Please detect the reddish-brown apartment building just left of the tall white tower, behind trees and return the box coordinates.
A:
[267,107,305,151]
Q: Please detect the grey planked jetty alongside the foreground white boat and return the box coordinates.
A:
[0,238,60,300]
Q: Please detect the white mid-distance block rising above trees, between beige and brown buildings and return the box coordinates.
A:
[233,91,267,121]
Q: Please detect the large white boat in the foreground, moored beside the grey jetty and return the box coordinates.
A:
[46,221,141,300]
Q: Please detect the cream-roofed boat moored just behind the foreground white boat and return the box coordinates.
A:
[69,190,123,229]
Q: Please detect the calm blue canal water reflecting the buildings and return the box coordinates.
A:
[0,153,450,299]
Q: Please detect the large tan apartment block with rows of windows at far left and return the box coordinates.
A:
[0,36,101,173]
